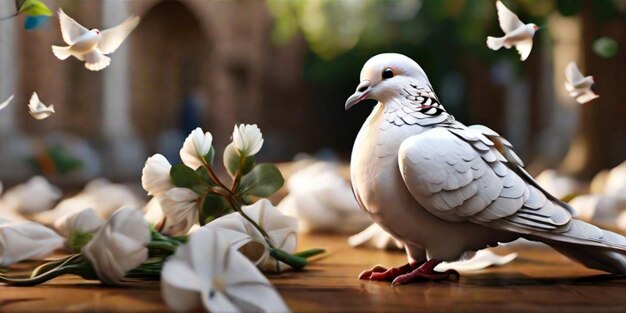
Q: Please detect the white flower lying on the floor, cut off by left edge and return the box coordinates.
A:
[0,222,63,266]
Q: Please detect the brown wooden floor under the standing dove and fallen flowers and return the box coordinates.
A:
[0,236,626,312]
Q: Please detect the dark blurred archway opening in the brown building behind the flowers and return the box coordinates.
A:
[130,1,212,158]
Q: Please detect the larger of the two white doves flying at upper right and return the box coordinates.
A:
[487,0,539,61]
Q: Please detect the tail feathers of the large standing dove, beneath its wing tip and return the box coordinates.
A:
[532,219,626,274]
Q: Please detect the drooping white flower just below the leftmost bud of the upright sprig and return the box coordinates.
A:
[159,188,199,236]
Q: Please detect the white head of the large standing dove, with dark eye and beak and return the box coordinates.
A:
[346,53,432,110]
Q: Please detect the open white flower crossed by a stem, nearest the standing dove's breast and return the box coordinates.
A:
[205,199,298,272]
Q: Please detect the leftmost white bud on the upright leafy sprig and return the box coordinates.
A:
[141,154,174,196]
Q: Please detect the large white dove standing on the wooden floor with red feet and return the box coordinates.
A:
[346,53,626,285]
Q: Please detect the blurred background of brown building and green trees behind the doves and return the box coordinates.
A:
[0,0,626,187]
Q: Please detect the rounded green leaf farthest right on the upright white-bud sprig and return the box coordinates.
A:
[238,163,285,197]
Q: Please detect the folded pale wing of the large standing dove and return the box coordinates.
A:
[398,123,626,250]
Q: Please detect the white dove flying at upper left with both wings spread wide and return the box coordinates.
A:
[52,8,140,71]
